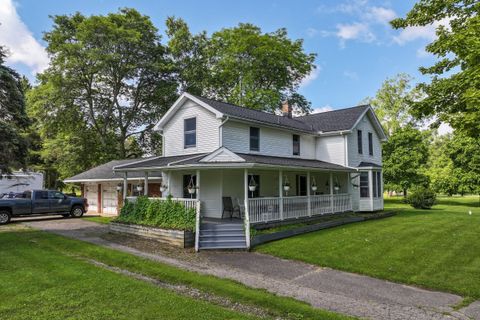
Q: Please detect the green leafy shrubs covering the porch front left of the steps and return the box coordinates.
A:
[115,197,195,231]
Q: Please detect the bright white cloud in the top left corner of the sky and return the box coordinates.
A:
[0,0,49,73]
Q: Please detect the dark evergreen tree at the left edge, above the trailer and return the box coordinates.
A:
[0,46,29,174]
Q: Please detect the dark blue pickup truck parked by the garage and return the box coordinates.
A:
[0,190,88,225]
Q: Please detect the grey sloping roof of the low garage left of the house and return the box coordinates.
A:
[63,158,162,183]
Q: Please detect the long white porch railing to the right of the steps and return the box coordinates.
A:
[248,194,352,223]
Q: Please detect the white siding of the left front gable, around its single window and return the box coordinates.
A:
[163,101,221,156]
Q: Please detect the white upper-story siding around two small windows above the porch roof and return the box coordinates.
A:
[222,121,315,159]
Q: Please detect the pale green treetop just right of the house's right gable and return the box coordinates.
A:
[365,73,422,135]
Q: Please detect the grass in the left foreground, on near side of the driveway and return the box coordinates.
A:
[0,225,348,320]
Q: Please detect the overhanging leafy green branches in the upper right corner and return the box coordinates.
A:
[392,0,480,142]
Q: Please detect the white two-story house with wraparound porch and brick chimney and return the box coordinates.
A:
[64,93,386,250]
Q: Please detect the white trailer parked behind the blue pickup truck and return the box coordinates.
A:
[0,171,43,195]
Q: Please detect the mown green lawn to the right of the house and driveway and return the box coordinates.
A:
[256,197,480,299]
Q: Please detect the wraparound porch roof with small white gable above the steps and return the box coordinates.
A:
[113,151,357,172]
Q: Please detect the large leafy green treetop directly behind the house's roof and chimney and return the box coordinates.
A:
[167,18,315,112]
